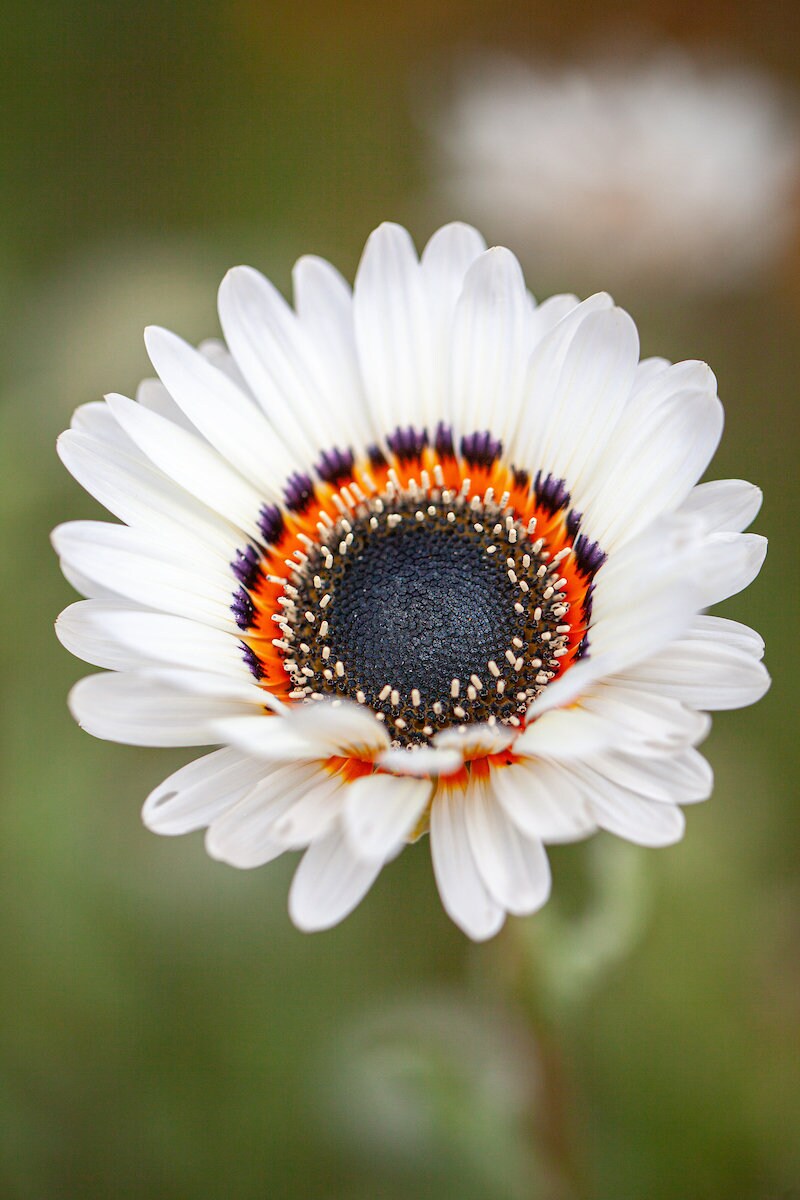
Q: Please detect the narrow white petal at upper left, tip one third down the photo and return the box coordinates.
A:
[106,395,264,540]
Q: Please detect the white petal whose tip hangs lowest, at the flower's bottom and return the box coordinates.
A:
[431,784,505,942]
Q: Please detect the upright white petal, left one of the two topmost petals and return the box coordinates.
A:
[353,223,439,432]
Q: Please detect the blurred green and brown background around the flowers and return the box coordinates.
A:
[0,0,800,1200]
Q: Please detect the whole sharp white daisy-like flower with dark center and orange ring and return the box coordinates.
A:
[54,224,769,938]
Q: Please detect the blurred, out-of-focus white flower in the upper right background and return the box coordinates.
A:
[433,50,800,292]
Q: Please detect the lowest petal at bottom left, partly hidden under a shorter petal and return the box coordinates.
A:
[289,828,383,931]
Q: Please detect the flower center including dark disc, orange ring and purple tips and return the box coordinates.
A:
[231,431,604,746]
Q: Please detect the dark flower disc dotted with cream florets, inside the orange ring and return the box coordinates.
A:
[278,491,571,745]
